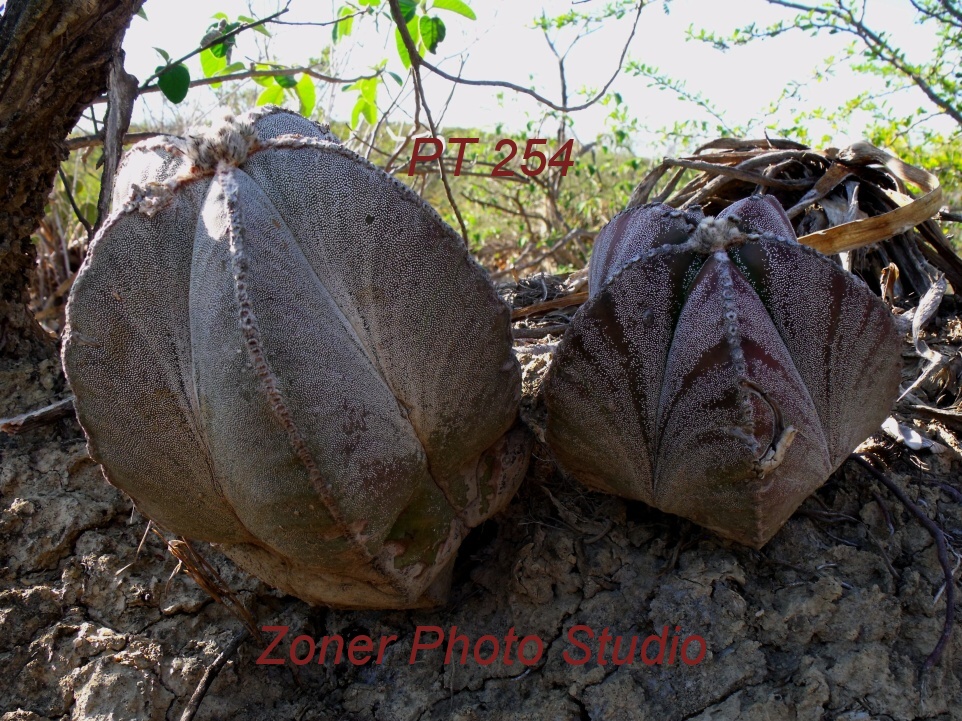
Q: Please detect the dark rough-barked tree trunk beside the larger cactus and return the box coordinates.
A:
[0,0,142,360]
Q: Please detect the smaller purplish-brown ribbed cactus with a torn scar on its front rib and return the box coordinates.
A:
[545,196,900,548]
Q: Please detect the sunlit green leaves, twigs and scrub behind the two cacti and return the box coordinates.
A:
[32,0,962,332]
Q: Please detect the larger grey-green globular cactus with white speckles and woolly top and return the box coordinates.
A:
[63,108,527,608]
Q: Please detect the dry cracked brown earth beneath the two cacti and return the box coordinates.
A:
[0,296,962,721]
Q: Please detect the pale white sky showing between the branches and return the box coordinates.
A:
[116,0,948,150]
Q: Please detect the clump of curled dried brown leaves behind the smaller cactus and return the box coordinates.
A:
[629,138,962,297]
